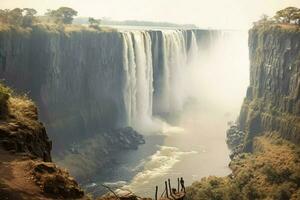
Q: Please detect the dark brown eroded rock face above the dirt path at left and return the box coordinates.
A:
[0,98,52,162]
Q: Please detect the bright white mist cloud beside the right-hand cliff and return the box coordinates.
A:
[185,31,249,114]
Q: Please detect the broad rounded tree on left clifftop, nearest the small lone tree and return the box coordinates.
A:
[46,7,77,24]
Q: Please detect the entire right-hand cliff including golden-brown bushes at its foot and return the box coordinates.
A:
[187,25,300,200]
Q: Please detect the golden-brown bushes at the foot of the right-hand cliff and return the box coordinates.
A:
[187,133,300,200]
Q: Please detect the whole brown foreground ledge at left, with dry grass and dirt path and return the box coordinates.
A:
[0,84,85,200]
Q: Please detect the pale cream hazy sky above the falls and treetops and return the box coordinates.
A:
[0,0,300,28]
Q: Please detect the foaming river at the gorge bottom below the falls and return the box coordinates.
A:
[89,103,235,197]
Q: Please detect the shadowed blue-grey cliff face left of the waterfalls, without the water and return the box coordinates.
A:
[0,28,124,150]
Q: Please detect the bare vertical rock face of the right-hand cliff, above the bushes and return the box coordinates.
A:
[239,27,300,151]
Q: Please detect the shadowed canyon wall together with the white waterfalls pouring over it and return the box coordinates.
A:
[0,26,217,151]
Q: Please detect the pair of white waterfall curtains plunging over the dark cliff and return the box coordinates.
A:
[122,30,198,129]
